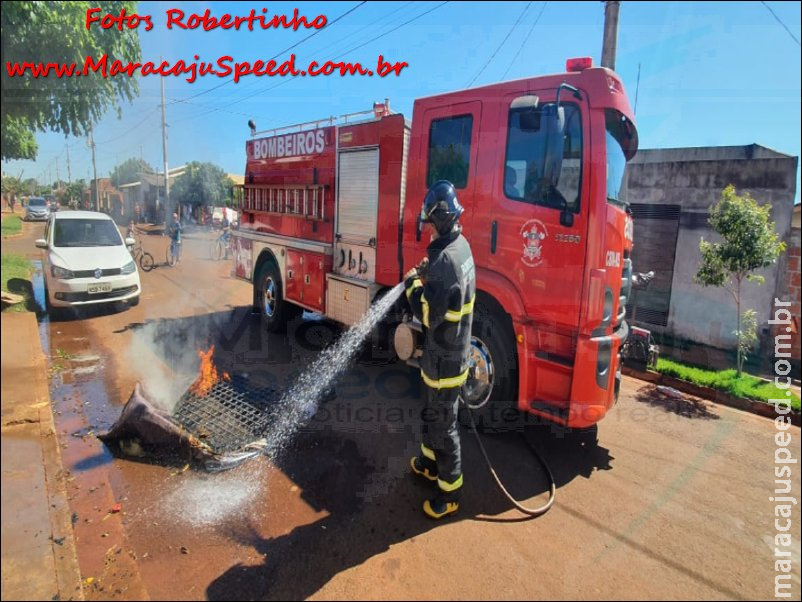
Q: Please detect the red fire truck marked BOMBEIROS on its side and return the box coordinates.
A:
[233,59,638,428]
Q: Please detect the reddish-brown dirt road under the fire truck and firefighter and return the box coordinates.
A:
[3,220,802,600]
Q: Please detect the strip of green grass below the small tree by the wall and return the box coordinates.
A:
[657,357,800,411]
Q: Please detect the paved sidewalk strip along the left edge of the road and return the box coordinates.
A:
[0,313,84,600]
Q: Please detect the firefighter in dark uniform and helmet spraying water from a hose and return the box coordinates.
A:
[404,180,476,519]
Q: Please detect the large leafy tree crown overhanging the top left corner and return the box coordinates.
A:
[0,0,141,159]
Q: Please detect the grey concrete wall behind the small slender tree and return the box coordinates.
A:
[628,145,798,348]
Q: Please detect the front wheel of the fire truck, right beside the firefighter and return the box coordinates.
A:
[460,304,519,432]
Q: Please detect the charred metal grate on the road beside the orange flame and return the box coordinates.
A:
[172,376,279,454]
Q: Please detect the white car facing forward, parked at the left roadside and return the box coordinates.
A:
[36,211,141,308]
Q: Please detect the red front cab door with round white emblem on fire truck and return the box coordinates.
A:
[471,89,589,332]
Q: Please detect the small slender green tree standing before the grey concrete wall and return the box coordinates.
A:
[694,184,785,376]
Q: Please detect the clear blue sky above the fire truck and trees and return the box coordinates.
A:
[2,0,802,202]
